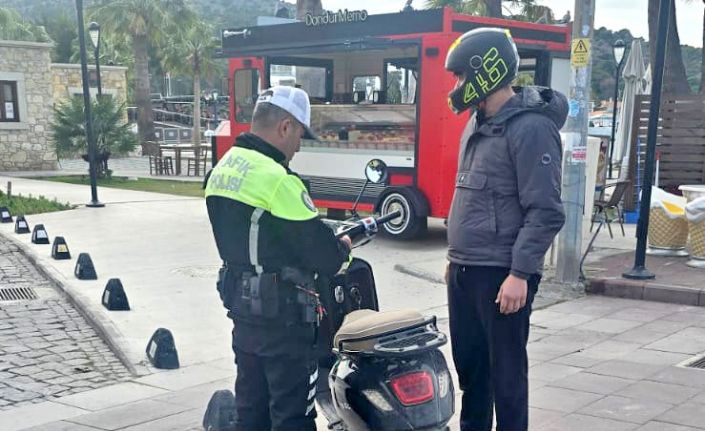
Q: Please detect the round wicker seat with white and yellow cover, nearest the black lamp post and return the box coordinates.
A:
[647,187,688,256]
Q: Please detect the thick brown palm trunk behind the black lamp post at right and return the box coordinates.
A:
[648,0,690,94]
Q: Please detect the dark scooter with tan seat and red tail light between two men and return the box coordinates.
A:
[203,159,455,431]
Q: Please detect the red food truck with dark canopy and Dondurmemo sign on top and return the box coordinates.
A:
[216,8,570,238]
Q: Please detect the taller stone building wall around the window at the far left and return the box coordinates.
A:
[0,41,57,172]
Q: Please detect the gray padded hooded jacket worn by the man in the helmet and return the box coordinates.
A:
[448,87,568,278]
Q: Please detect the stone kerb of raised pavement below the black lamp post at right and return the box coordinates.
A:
[587,278,705,307]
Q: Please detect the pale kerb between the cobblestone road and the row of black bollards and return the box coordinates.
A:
[0,233,151,377]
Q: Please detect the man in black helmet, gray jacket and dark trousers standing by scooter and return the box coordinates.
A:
[446,28,567,431]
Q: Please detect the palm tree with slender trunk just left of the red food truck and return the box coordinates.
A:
[163,21,219,155]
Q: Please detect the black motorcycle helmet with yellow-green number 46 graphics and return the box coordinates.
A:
[446,27,519,114]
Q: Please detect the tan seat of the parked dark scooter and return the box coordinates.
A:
[333,310,424,352]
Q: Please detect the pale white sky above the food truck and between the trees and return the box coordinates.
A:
[322,0,704,47]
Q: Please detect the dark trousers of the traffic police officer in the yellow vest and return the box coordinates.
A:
[235,349,318,431]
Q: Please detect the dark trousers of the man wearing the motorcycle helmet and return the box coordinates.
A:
[448,264,540,431]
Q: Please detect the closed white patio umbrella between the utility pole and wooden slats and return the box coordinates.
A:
[612,40,646,179]
